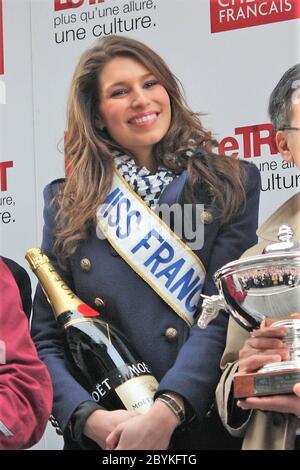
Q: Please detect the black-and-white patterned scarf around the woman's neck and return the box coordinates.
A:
[115,154,175,210]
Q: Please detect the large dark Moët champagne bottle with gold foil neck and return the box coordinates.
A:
[25,248,158,413]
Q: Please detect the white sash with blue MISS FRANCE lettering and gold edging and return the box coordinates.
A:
[97,169,205,326]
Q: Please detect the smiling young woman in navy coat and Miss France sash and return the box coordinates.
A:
[32,36,260,449]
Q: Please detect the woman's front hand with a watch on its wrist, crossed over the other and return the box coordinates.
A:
[106,400,179,450]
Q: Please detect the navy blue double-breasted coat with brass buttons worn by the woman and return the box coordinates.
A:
[32,164,260,449]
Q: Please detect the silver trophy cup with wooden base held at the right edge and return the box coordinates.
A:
[198,225,300,398]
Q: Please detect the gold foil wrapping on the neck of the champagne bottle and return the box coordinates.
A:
[25,248,83,317]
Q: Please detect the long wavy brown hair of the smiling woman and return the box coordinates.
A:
[55,36,245,261]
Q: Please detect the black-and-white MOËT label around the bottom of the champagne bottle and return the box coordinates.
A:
[91,362,158,413]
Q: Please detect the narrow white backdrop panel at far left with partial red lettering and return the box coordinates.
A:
[0,1,37,265]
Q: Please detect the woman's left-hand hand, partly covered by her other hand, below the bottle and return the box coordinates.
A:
[83,410,138,449]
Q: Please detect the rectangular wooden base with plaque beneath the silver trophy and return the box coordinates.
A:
[234,367,300,398]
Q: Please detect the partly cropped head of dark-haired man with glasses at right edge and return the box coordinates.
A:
[269,64,300,169]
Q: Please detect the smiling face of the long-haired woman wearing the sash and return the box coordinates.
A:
[99,57,171,166]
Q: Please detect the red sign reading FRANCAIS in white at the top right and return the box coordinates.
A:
[210,0,300,33]
